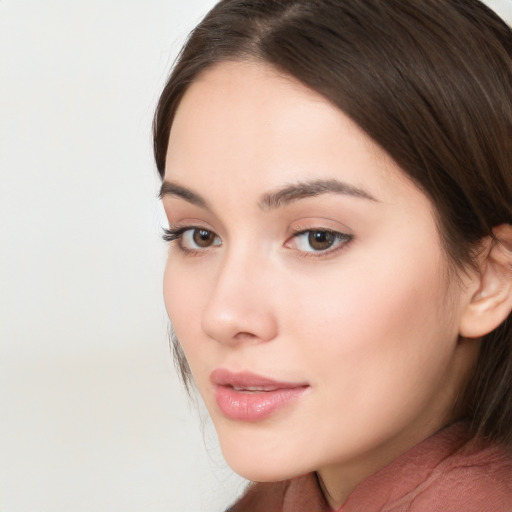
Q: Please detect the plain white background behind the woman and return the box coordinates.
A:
[0,0,512,512]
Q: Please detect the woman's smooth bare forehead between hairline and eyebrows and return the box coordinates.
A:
[166,62,415,204]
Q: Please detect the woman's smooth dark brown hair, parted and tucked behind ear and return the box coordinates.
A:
[154,0,512,442]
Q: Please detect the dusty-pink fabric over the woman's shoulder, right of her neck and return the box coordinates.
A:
[342,423,512,512]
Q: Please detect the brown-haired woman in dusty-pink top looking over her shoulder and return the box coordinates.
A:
[154,0,512,512]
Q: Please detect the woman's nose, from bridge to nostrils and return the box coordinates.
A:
[201,250,278,345]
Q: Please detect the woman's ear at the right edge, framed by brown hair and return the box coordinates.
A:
[459,224,512,338]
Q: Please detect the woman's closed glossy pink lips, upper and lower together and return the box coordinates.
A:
[210,368,308,422]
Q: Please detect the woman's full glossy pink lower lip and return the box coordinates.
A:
[215,386,307,421]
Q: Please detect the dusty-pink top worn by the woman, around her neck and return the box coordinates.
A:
[228,423,512,512]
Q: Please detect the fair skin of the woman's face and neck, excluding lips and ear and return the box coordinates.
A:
[163,62,478,507]
